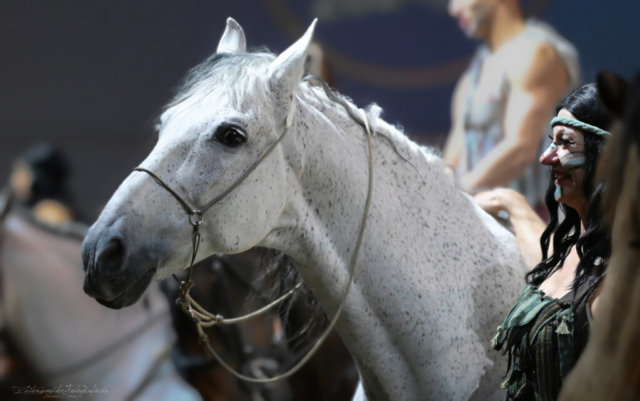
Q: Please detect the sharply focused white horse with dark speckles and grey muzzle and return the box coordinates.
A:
[83,19,526,401]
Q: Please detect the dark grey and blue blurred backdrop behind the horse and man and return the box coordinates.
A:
[0,0,640,222]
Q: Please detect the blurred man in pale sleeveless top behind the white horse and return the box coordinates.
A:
[444,0,580,214]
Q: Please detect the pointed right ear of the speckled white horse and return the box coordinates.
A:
[267,18,318,98]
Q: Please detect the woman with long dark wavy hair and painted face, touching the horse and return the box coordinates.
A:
[476,84,611,401]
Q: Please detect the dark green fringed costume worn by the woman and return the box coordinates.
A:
[492,281,595,401]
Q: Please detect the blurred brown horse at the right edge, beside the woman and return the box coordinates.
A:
[560,73,640,401]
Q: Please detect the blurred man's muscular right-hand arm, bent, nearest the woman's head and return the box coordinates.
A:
[460,43,569,191]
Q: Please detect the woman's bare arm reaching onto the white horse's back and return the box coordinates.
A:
[474,188,547,269]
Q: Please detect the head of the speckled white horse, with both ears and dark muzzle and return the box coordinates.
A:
[82,18,315,308]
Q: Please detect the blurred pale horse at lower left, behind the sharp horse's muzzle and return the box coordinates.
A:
[0,198,200,401]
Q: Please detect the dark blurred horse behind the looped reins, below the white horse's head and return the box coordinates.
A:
[163,248,358,401]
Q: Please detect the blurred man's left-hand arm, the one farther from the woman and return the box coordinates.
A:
[442,72,469,168]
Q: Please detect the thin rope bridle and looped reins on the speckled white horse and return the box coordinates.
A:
[134,99,373,383]
